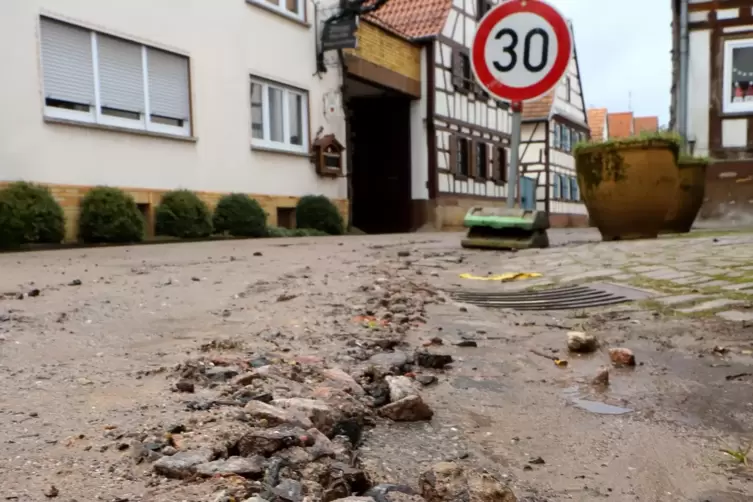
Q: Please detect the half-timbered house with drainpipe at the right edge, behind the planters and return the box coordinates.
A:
[670,0,753,217]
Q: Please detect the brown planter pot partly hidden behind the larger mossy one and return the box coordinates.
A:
[662,159,708,233]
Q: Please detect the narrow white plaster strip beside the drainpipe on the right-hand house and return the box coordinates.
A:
[688,31,711,156]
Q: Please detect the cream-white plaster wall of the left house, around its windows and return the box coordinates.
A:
[0,0,346,198]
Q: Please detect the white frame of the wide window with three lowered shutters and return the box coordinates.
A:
[40,18,193,137]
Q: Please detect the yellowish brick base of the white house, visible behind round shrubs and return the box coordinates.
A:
[0,181,348,242]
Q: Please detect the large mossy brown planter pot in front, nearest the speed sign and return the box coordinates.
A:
[575,138,679,241]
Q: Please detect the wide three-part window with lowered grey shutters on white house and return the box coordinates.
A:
[41,17,191,136]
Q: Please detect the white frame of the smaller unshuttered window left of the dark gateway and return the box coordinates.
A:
[248,76,309,153]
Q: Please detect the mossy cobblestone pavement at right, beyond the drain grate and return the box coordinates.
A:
[452,229,753,322]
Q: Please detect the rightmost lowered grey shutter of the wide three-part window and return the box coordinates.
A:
[147,48,191,120]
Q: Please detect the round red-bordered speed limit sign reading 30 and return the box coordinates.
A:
[471,0,573,102]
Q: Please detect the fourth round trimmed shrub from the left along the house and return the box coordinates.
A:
[213,193,267,237]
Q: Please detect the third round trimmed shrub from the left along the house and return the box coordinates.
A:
[155,190,214,239]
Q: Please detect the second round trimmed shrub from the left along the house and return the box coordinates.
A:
[78,186,146,244]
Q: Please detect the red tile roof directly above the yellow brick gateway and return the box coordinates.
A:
[364,0,452,38]
